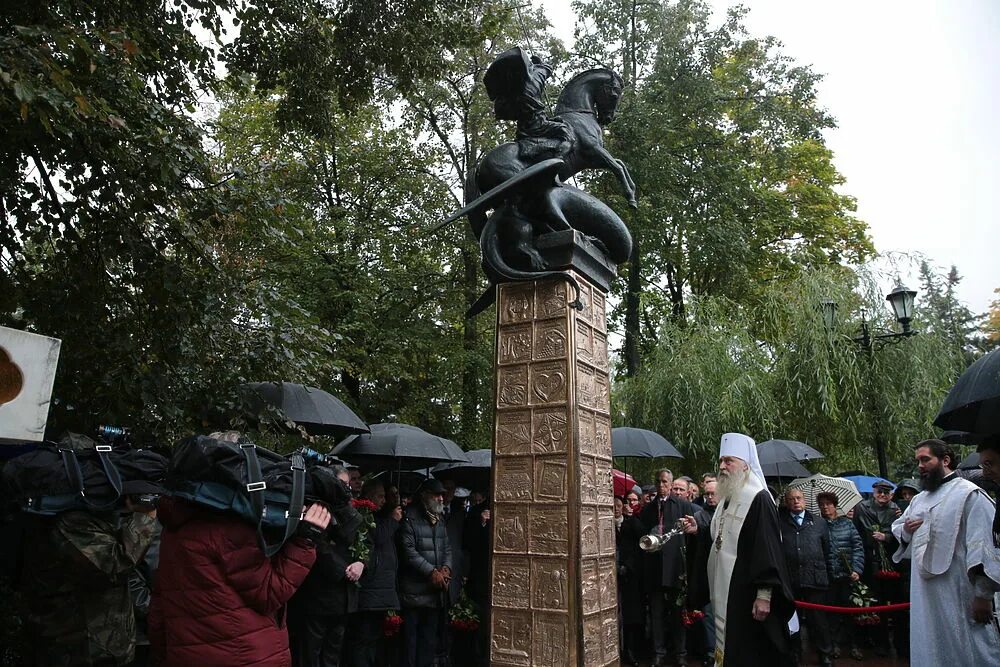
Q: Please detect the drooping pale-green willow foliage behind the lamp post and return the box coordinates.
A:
[615,270,965,473]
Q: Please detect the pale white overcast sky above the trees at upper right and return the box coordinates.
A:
[540,0,1000,312]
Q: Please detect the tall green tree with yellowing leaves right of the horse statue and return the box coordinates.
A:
[574,0,873,374]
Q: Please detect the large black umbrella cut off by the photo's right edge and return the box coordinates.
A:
[934,350,1000,434]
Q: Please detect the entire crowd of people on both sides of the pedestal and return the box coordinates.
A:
[3,433,1000,667]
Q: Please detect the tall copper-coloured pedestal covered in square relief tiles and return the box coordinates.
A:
[490,237,618,667]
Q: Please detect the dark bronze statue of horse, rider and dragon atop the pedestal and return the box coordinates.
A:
[442,49,636,314]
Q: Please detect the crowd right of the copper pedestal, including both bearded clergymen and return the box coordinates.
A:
[615,434,1000,667]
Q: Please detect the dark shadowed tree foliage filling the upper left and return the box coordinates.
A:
[0,0,484,444]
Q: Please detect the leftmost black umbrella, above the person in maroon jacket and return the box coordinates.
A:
[240,382,368,436]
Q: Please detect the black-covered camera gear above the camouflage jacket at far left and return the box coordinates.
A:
[2,435,167,516]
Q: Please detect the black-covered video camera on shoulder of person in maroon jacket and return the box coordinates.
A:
[166,435,310,557]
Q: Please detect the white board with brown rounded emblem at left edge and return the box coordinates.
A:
[0,327,61,445]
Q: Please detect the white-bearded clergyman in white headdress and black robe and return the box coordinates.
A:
[687,433,795,667]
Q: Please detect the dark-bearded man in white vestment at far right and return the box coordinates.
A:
[892,440,1000,667]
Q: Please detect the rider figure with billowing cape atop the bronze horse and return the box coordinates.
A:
[483,47,572,162]
